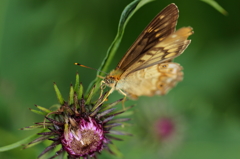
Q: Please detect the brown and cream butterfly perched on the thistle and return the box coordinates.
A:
[102,3,193,99]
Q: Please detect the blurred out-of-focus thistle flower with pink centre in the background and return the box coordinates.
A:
[135,99,185,158]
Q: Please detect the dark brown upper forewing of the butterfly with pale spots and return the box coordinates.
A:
[116,4,178,72]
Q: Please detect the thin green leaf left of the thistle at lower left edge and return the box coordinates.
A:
[0,129,45,152]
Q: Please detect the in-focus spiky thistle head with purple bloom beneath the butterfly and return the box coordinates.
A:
[23,74,130,159]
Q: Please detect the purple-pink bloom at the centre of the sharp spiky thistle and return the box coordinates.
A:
[61,117,108,157]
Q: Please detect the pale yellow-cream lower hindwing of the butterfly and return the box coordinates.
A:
[116,62,183,98]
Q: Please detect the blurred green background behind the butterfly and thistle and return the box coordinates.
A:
[0,0,240,159]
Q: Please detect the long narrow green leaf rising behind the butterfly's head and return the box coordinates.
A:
[87,0,153,93]
